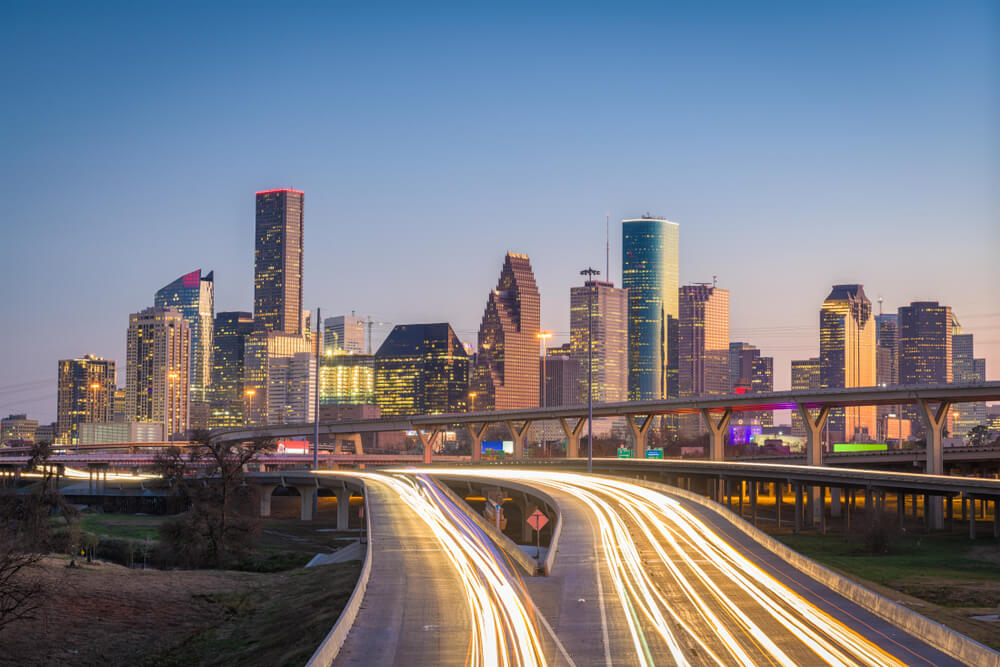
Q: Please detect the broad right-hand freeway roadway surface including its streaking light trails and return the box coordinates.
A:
[432,470,976,665]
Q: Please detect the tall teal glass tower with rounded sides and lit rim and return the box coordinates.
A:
[622,217,680,401]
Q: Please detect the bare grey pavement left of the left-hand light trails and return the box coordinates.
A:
[334,476,472,667]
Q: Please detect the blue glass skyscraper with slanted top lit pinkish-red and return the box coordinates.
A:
[153,269,215,402]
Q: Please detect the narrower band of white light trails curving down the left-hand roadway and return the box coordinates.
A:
[319,472,545,667]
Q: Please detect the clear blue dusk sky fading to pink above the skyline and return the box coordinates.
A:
[0,0,1000,421]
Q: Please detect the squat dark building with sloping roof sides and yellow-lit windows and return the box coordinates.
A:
[375,323,468,417]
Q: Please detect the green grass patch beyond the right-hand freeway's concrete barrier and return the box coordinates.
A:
[774,533,1000,649]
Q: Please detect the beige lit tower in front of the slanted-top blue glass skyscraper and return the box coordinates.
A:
[125,306,191,437]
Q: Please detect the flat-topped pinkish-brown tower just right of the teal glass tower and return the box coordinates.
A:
[677,284,729,436]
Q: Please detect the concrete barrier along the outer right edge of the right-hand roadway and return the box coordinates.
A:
[624,475,1000,667]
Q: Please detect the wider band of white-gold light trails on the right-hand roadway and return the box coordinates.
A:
[410,469,903,666]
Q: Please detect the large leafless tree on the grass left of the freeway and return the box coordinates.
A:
[157,430,274,567]
